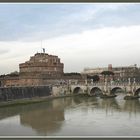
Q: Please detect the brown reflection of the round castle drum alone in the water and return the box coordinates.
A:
[20,104,65,135]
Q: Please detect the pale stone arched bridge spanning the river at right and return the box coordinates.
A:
[69,82,140,96]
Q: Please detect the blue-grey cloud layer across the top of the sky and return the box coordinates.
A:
[0,3,140,42]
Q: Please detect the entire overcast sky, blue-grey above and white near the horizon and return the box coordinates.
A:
[0,3,140,74]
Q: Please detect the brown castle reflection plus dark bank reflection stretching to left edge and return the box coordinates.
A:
[0,99,65,135]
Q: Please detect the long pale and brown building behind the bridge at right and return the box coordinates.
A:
[81,64,140,82]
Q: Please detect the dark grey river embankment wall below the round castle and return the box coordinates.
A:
[0,86,52,101]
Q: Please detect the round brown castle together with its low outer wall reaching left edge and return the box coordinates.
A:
[0,53,64,86]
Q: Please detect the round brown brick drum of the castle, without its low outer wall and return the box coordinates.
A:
[19,53,64,78]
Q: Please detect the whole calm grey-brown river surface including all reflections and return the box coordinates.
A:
[0,93,140,136]
